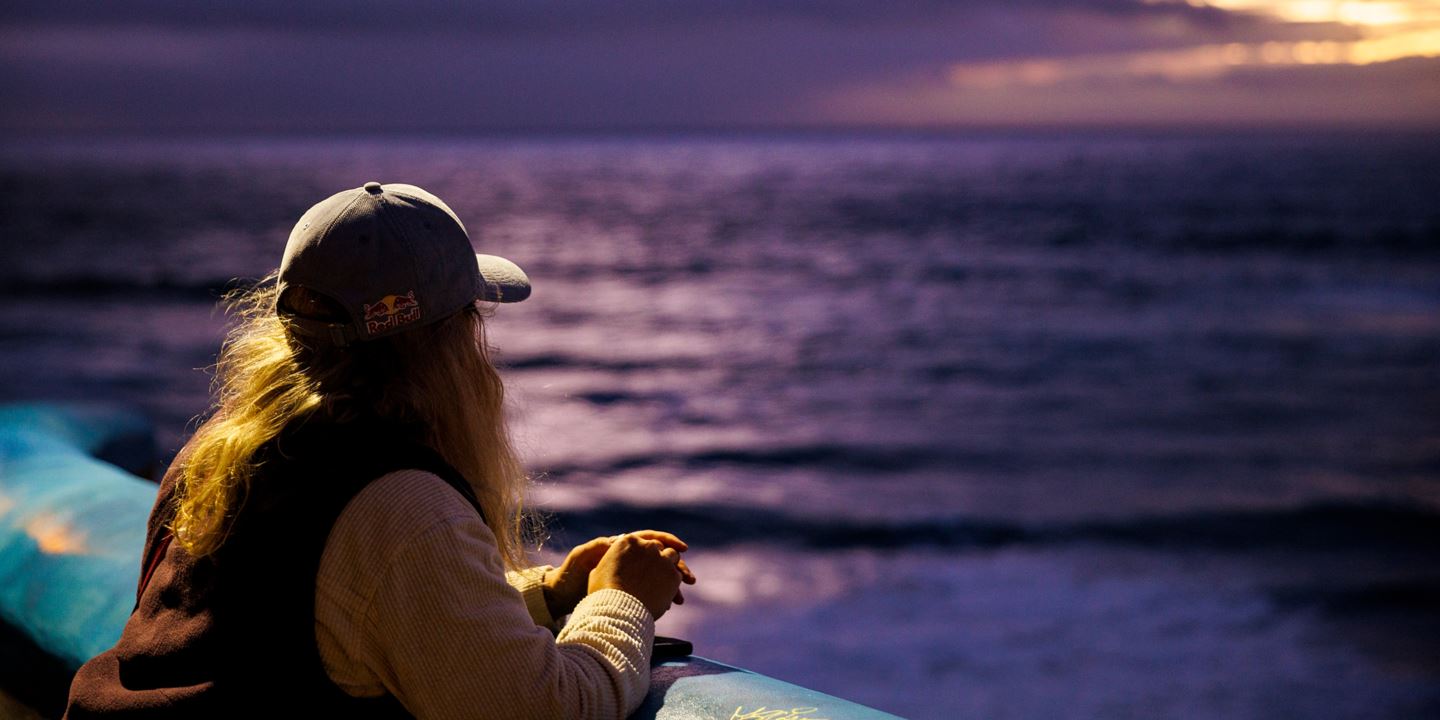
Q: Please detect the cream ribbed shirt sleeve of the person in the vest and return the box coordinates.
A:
[315,469,655,720]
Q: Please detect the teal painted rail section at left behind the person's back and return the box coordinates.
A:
[0,405,156,668]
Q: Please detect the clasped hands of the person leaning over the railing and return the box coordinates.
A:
[543,530,696,619]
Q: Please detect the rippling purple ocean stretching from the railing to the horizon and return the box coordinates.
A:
[0,132,1440,720]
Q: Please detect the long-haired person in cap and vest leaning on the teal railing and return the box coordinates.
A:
[66,183,694,720]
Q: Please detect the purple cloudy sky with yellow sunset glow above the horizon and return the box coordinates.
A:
[0,0,1440,132]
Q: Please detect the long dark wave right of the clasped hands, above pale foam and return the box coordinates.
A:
[552,500,1440,553]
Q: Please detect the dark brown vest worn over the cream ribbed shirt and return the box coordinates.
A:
[65,420,484,720]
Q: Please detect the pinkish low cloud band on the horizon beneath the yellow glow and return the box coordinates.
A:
[814,58,1440,128]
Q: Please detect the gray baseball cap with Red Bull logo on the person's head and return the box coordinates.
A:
[275,183,530,346]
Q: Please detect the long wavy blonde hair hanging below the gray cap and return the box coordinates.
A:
[171,272,539,569]
